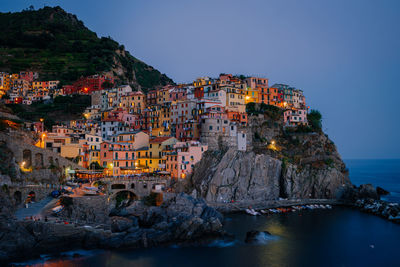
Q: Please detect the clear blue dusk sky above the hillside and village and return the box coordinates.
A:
[0,0,400,159]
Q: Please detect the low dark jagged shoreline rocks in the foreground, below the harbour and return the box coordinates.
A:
[0,194,227,263]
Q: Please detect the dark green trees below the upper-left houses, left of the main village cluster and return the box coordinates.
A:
[6,95,90,130]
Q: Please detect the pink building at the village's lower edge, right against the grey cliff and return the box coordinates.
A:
[166,141,208,179]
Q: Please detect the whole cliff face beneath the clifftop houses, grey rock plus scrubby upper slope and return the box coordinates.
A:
[189,116,351,202]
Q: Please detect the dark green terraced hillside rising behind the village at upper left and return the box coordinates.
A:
[0,7,173,89]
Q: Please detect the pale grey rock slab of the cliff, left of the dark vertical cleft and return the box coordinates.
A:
[193,149,282,202]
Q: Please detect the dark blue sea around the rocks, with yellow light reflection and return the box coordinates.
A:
[13,160,400,267]
